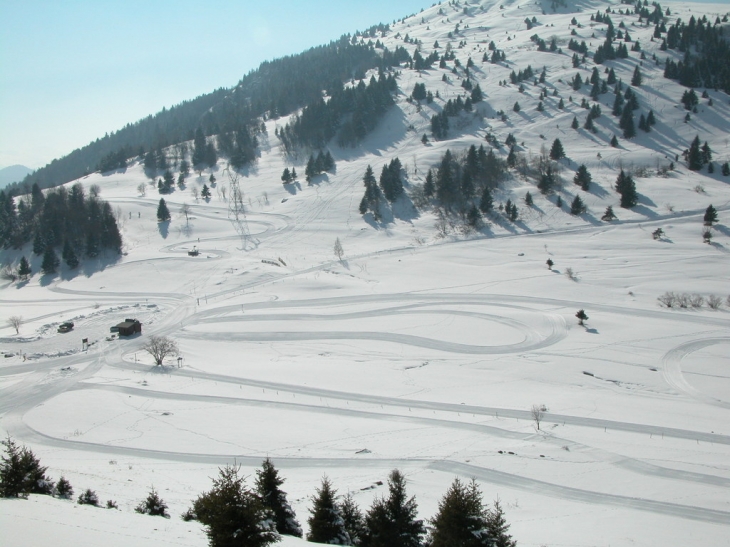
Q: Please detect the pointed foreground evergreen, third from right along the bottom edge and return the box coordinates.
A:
[363,469,426,547]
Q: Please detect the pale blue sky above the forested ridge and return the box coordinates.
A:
[0,0,431,168]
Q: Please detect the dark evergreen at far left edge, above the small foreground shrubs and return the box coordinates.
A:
[0,437,53,498]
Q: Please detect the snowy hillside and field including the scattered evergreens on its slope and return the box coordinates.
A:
[0,0,730,546]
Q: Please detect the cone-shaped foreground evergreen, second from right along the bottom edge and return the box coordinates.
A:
[428,478,496,547]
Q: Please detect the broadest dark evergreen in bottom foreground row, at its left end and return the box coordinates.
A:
[188,466,280,547]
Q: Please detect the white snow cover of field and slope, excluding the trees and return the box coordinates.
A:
[0,1,730,546]
